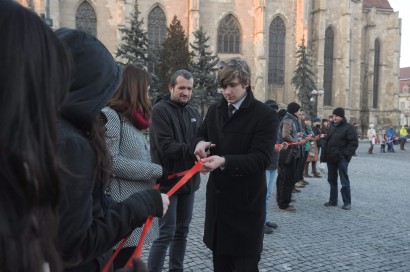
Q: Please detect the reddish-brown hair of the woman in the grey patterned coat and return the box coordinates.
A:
[108,64,152,122]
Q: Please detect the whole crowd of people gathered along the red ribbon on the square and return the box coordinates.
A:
[0,0,408,272]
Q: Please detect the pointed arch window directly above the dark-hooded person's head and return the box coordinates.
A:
[75,1,97,36]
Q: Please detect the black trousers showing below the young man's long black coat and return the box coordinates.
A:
[213,253,261,272]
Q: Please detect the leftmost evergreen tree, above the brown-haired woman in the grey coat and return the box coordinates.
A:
[116,1,160,103]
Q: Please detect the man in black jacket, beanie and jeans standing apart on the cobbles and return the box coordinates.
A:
[320,108,359,210]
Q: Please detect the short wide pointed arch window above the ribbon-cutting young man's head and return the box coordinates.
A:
[218,14,241,54]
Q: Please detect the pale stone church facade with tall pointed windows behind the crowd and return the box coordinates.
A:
[18,0,401,129]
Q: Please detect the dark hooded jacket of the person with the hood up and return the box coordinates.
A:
[57,29,163,272]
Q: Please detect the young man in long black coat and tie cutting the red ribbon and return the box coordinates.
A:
[193,59,276,272]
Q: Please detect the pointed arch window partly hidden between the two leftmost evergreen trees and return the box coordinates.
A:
[148,6,167,74]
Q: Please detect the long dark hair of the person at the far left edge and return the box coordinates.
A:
[0,0,70,272]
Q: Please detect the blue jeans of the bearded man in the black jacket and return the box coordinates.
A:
[148,193,195,272]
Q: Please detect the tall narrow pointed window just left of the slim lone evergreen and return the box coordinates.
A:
[268,16,286,85]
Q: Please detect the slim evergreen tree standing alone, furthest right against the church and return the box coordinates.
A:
[291,39,317,117]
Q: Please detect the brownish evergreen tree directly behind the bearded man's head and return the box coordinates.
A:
[158,16,191,93]
